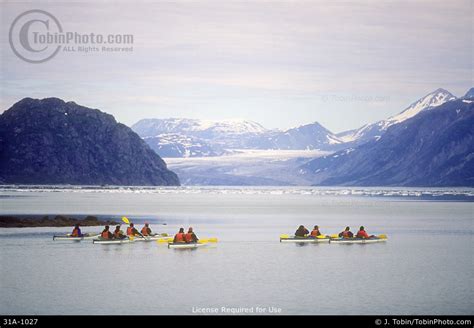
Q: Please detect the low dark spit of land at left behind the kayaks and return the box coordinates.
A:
[0,215,119,228]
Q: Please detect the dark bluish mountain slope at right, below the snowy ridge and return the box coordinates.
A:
[301,100,474,186]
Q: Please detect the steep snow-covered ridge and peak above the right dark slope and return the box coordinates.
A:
[336,88,456,146]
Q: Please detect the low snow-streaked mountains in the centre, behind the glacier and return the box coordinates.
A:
[132,118,342,157]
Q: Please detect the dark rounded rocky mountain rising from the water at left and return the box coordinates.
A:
[0,98,179,185]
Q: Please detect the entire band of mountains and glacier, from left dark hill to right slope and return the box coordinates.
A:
[0,89,474,186]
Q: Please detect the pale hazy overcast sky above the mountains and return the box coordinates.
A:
[0,0,474,132]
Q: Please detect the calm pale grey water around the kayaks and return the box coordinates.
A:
[0,188,474,314]
